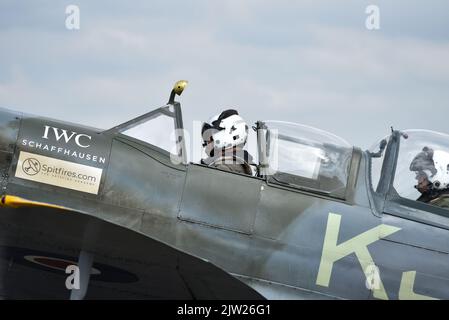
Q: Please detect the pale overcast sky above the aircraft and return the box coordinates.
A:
[0,0,449,155]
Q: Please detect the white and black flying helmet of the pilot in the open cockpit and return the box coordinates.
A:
[201,109,248,149]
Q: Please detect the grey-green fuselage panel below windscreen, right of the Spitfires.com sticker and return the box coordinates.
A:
[103,139,185,217]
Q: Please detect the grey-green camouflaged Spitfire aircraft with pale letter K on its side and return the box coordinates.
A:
[0,81,449,300]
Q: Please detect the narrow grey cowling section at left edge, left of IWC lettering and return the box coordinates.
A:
[0,108,21,185]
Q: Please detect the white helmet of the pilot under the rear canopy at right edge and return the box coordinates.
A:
[410,147,449,190]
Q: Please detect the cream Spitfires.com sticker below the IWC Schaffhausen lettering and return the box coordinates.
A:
[16,151,103,194]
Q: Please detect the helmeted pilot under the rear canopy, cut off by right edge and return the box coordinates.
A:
[410,147,449,207]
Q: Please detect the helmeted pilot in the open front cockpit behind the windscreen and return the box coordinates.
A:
[201,109,254,175]
